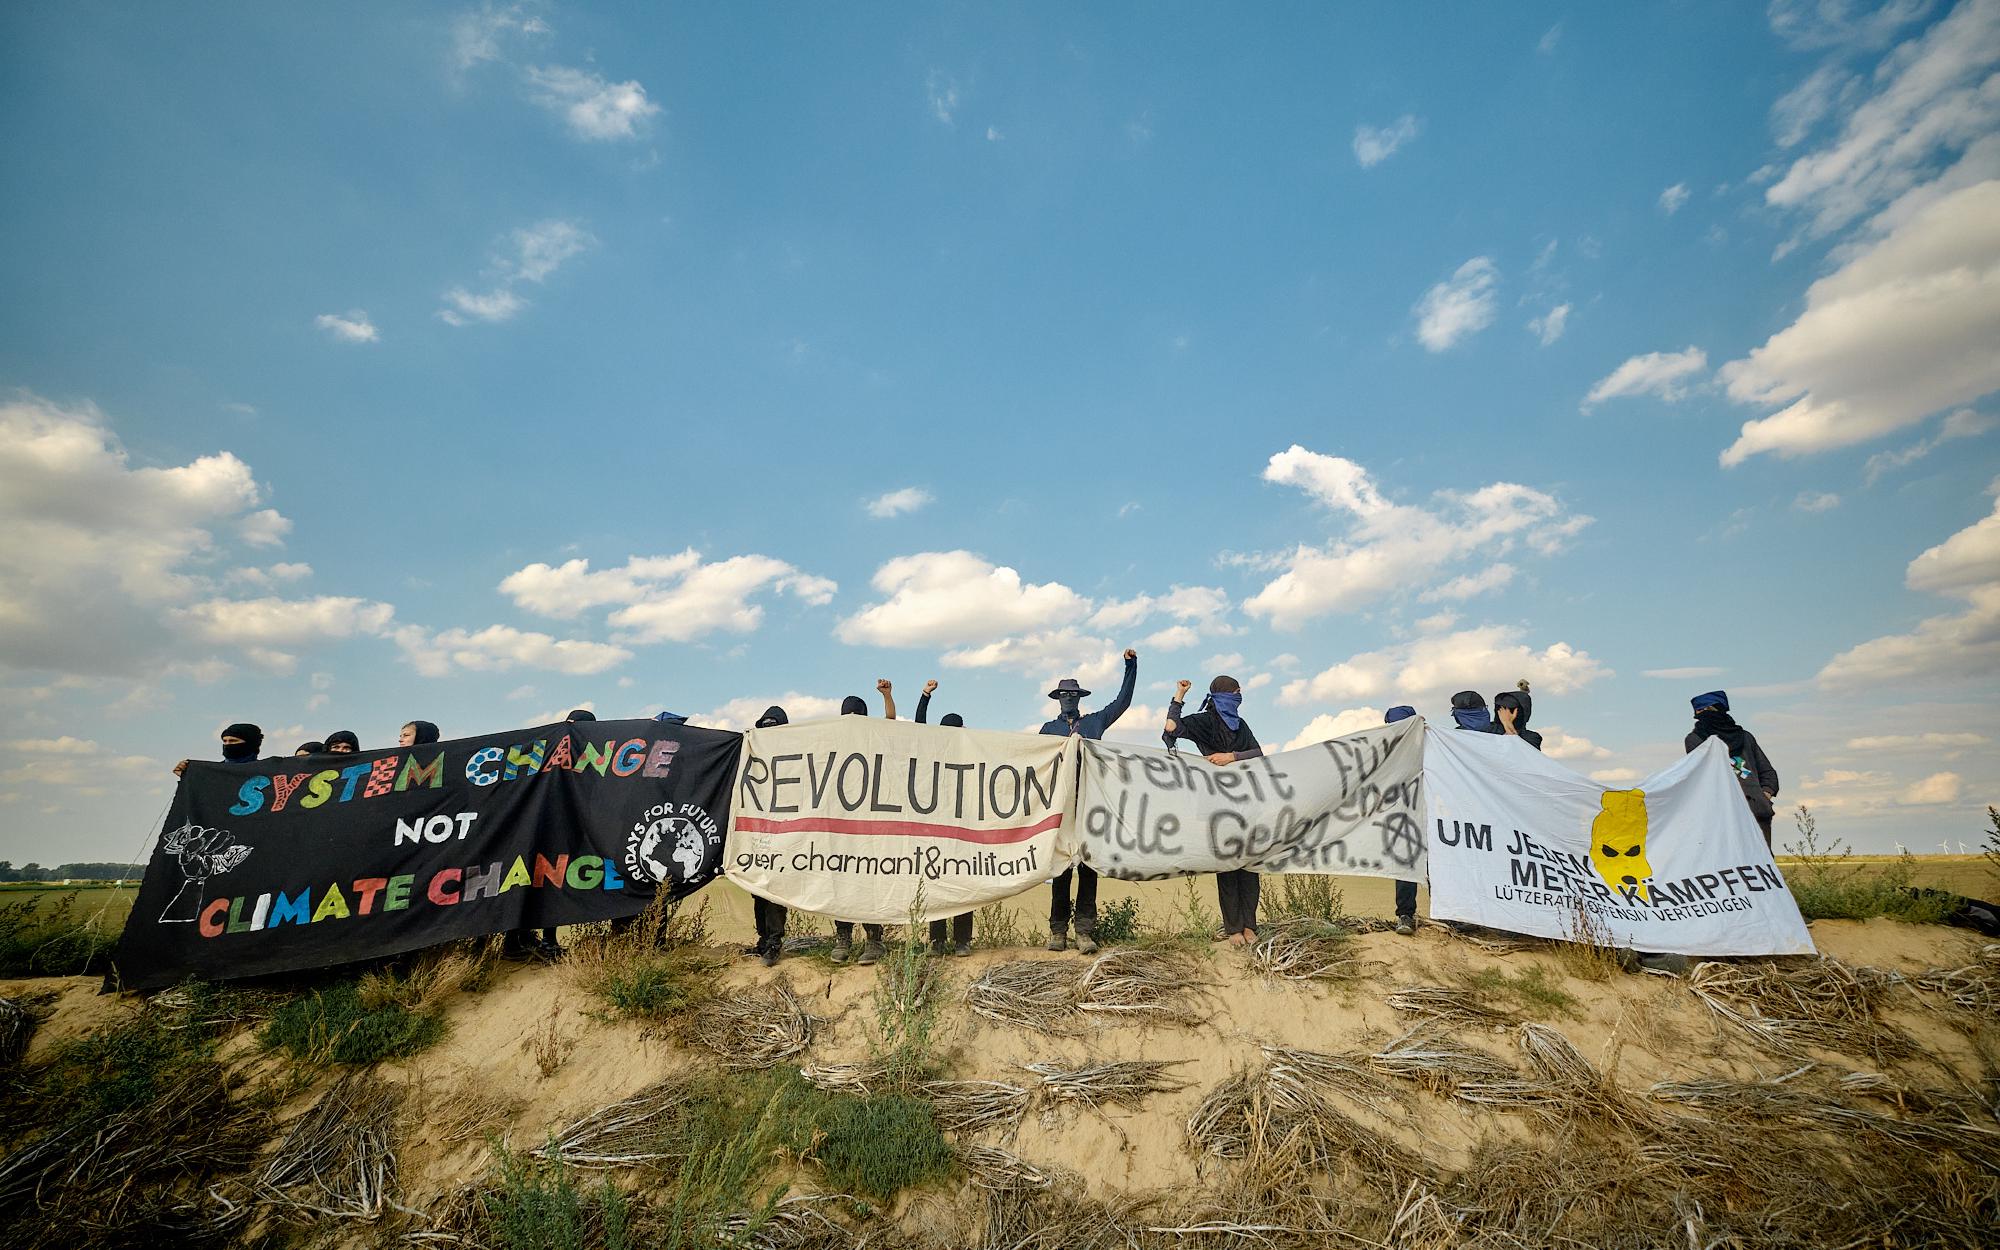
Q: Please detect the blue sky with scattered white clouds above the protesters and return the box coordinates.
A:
[0,0,2000,862]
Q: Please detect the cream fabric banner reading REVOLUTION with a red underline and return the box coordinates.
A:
[724,716,1078,924]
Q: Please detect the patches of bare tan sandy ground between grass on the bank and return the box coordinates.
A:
[15,896,1982,1200]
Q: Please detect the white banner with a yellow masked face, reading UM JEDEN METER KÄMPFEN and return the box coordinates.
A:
[1424,730,1812,954]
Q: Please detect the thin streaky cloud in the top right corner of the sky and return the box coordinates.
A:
[1764,0,2000,238]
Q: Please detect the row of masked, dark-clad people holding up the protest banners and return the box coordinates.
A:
[174,648,1778,966]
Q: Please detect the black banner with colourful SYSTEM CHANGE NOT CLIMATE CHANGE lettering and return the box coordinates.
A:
[116,720,742,990]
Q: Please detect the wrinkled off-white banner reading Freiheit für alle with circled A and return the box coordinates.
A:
[1076,718,1424,880]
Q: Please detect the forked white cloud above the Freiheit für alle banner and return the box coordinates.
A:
[1244,444,1590,630]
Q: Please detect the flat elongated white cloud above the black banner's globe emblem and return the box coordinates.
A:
[500,548,838,642]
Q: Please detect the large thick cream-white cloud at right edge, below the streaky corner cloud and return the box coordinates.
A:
[1720,180,2000,466]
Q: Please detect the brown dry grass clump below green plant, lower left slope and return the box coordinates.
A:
[258,1072,404,1220]
